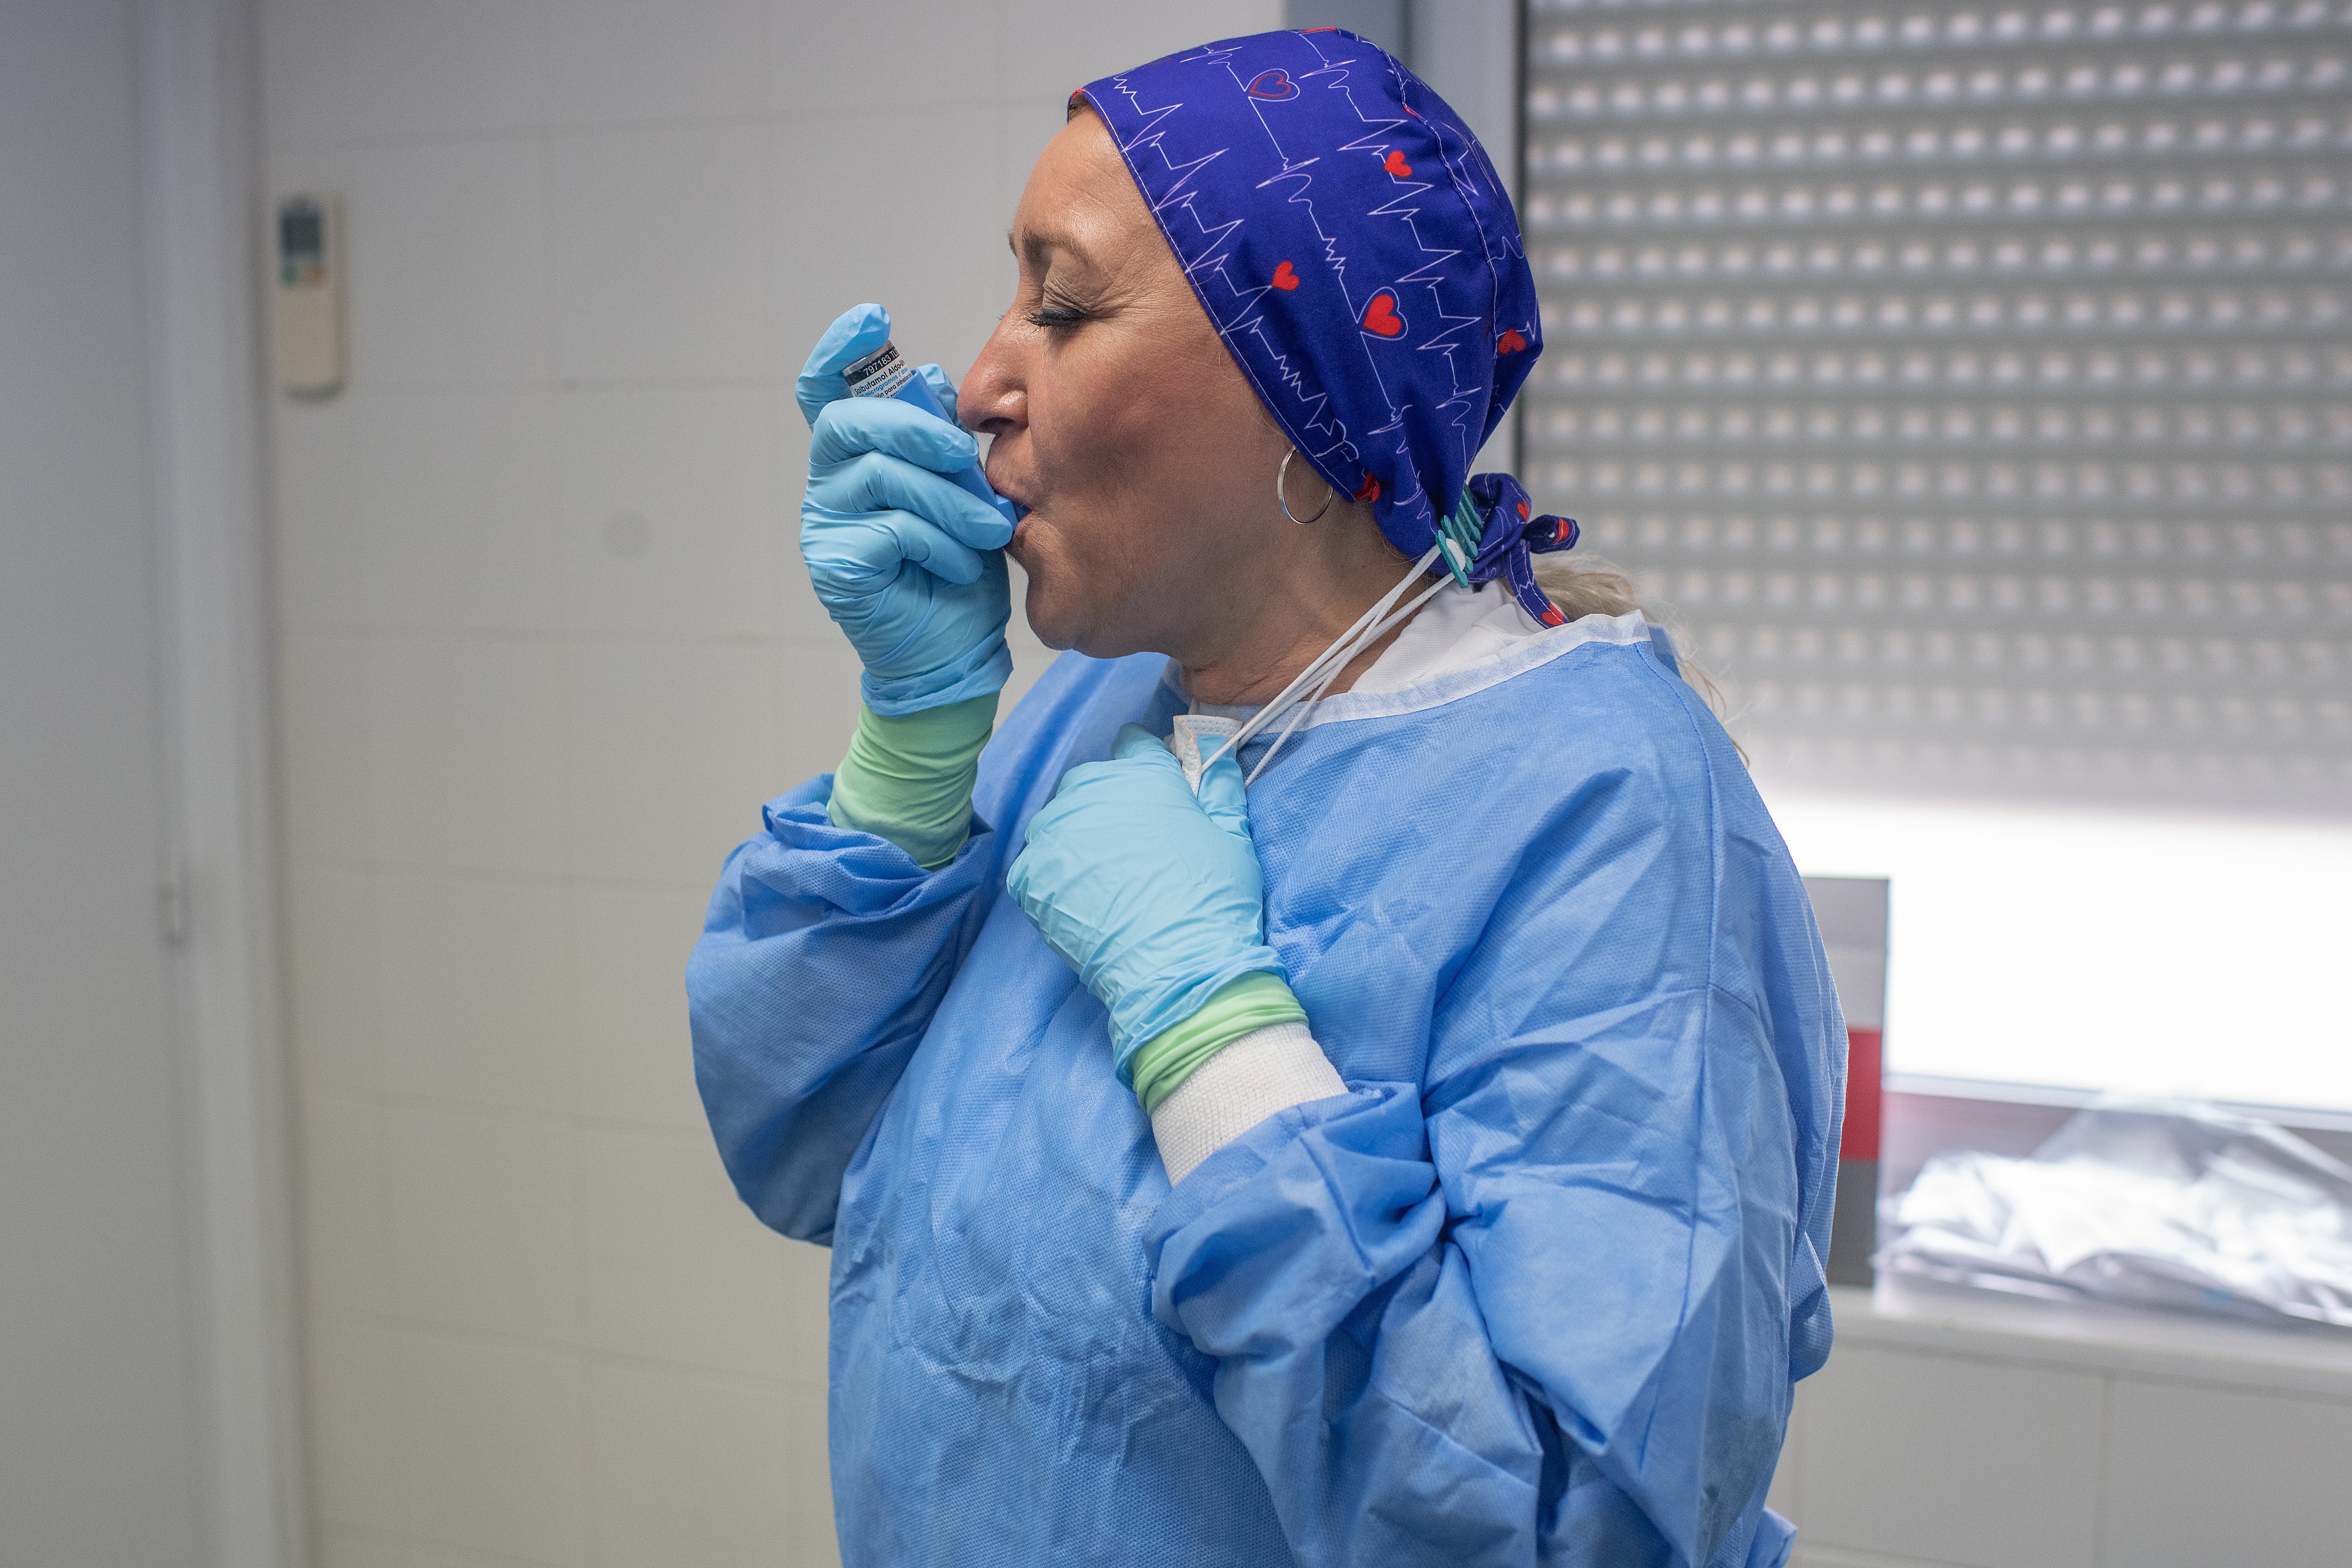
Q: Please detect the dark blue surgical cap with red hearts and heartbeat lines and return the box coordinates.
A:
[1070,28,1576,623]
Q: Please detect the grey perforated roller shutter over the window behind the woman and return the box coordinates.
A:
[1522,0,2352,813]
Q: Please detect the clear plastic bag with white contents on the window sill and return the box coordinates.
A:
[1877,1100,2352,1328]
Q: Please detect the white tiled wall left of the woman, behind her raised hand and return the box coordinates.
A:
[263,0,1280,1568]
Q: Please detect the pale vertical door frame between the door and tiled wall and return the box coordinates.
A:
[134,0,311,1568]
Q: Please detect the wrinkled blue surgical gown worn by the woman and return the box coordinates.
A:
[687,616,1844,1568]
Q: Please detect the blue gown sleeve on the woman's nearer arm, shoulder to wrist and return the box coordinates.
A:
[1145,691,1844,1568]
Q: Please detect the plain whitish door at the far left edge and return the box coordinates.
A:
[0,0,202,1568]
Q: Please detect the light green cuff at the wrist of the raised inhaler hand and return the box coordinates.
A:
[826,691,997,872]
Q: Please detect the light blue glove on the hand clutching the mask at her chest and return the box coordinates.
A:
[1004,724,1289,1084]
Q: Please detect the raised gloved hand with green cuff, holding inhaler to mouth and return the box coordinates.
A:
[795,305,1014,867]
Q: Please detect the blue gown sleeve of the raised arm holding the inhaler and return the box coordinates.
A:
[687,774,1002,1241]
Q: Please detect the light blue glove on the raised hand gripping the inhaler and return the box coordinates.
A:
[797,305,1014,717]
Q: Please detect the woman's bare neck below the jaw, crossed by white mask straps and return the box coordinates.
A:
[1178,506,1411,708]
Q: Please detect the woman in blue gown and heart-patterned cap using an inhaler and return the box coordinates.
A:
[687,30,1844,1568]
